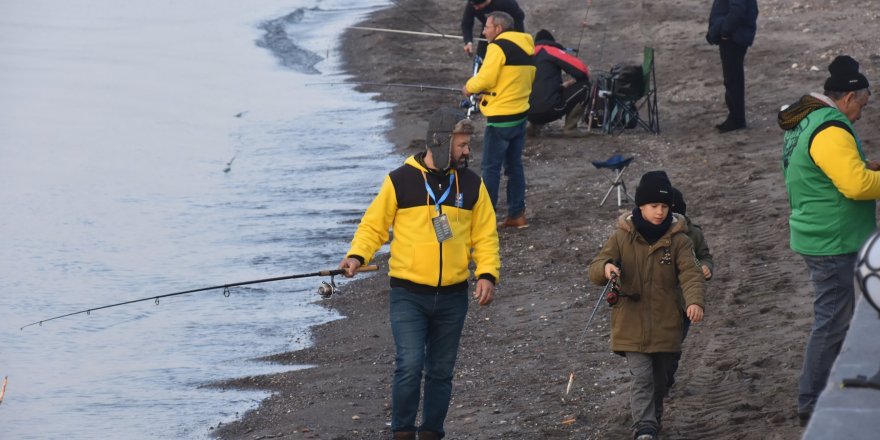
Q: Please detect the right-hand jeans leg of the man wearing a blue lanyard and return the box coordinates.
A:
[419,290,468,436]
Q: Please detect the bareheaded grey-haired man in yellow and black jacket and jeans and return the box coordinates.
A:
[462,11,535,228]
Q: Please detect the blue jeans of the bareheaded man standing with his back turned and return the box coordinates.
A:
[481,121,526,218]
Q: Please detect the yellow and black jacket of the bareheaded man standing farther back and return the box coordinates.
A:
[465,31,535,123]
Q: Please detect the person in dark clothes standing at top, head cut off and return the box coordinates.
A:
[706,0,758,133]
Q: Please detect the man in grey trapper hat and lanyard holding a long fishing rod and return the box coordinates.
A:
[339,109,501,440]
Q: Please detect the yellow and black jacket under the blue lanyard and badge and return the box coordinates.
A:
[347,153,501,293]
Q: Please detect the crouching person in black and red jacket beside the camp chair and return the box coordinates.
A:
[526,29,590,136]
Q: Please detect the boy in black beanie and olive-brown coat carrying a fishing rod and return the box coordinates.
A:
[589,171,705,440]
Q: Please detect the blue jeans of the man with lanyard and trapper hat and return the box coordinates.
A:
[390,287,468,435]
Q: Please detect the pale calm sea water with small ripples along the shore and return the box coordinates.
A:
[0,0,400,439]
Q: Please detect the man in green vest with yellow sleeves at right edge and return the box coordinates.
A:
[778,55,880,425]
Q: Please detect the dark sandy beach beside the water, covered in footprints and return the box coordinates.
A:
[213,0,880,440]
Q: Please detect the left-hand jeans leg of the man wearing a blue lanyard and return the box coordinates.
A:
[389,287,428,432]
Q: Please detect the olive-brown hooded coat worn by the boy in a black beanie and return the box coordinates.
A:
[589,214,706,353]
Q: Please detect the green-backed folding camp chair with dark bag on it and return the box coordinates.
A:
[590,47,660,135]
